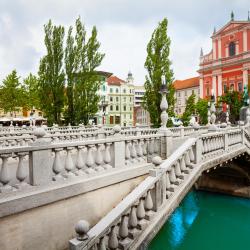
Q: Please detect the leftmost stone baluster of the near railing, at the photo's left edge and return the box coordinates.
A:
[0,154,12,193]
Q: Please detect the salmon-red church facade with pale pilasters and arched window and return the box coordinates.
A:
[198,13,250,98]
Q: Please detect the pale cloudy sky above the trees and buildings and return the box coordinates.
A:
[0,0,250,85]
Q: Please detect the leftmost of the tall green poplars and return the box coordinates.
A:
[38,20,65,125]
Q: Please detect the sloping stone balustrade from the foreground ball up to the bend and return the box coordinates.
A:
[69,138,196,250]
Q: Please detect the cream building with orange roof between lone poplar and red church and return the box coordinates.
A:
[173,77,200,116]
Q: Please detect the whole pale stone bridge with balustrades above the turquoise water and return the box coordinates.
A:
[0,123,250,250]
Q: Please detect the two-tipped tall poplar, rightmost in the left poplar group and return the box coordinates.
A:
[74,18,104,124]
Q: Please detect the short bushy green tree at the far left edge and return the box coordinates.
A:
[0,70,27,116]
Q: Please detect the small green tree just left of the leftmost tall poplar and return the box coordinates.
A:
[23,73,40,109]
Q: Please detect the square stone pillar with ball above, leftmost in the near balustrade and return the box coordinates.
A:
[29,128,52,186]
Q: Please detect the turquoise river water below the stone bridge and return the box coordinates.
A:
[148,191,250,250]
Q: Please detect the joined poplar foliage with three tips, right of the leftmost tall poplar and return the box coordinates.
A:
[65,18,104,124]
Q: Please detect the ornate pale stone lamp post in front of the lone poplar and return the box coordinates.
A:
[160,76,168,130]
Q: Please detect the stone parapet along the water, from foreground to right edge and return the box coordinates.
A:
[69,126,250,250]
